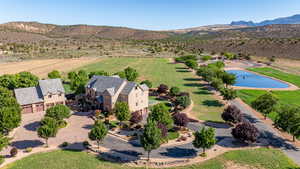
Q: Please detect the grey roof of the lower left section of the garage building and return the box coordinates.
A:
[14,87,44,105]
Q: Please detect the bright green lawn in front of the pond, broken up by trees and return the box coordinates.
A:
[238,90,300,120]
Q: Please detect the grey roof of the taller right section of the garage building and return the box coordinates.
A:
[39,79,65,96]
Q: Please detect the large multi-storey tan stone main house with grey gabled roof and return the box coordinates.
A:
[86,76,149,113]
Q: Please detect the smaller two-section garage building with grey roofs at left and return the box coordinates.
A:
[14,79,66,113]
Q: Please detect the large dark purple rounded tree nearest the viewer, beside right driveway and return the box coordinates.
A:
[231,122,259,143]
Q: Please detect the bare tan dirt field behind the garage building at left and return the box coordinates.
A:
[0,57,100,78]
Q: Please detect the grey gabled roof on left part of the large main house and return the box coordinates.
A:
[86,76,126,93]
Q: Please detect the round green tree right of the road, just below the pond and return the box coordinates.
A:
[251,92,278,119]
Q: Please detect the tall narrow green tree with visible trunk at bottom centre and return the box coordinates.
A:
[140,119,161,161]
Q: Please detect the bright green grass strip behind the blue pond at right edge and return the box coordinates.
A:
[248,67,300,87]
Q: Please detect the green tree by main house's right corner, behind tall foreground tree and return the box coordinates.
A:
[148,103,173,129]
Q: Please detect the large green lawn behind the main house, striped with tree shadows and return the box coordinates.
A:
[79,58,223,121]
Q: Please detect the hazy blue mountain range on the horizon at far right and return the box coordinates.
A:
[230,14,300,26]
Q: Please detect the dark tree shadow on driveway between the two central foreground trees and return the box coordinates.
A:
[160,147,197,158]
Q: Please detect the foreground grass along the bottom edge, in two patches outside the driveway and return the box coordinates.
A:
[2,148,297,169]
